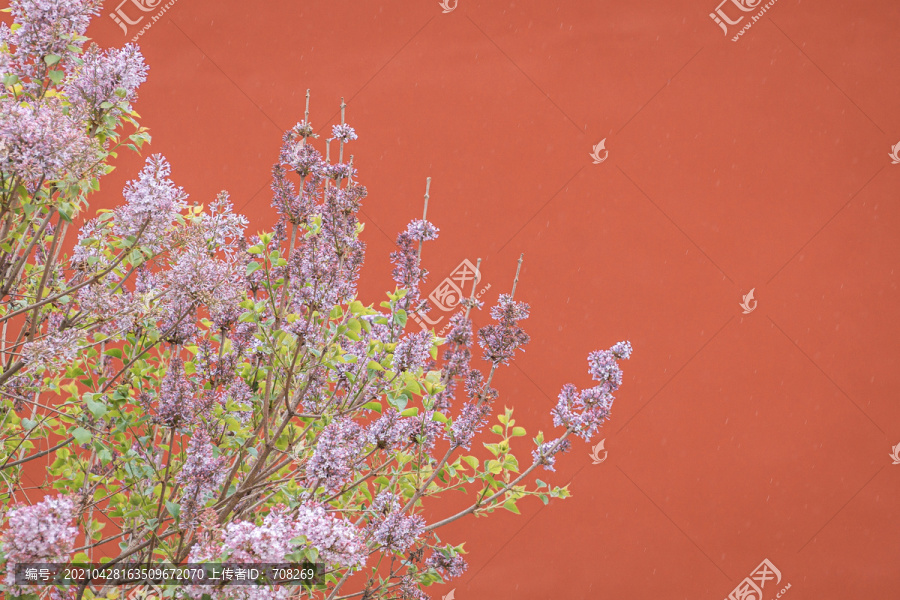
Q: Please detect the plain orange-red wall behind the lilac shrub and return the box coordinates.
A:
[65,0,900,600]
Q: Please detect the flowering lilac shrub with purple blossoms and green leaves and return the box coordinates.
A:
[0,0,631,600]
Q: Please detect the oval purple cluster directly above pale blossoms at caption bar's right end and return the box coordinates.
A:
[306,418,366,492]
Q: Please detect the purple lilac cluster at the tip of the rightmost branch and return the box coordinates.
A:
[551,342,631,441]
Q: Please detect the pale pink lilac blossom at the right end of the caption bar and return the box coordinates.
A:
[296,504,366,569]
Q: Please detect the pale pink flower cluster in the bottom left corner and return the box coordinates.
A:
[0,496,78,587]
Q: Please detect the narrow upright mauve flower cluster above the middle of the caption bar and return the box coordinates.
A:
[175,427,225,525]
